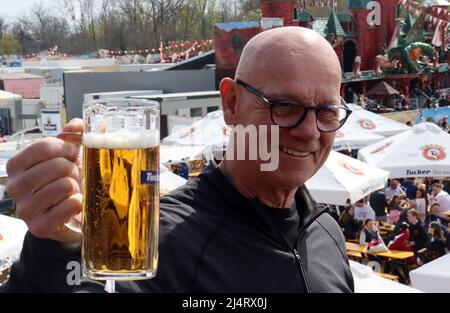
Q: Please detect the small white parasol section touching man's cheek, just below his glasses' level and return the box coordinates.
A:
[333,127,384,151]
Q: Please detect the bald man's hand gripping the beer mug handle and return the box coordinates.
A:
[6,119,83,243]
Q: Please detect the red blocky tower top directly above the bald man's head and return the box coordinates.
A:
[261,0,298,26]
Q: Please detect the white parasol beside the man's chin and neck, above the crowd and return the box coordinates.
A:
[306,151,389,205]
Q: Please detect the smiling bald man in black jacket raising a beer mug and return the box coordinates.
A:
[4,27,353,293]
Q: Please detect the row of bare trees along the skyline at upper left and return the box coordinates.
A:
[7,0,253,54]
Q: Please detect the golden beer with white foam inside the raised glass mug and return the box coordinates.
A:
[82,130,159,280]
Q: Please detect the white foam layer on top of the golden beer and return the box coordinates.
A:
[83,129,159,149]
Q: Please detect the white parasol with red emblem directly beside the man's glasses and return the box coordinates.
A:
[342,104,411,137]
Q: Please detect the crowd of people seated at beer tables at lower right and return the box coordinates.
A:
[339,178,450,265]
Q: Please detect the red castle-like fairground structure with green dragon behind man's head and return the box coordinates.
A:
[215,0,450,108]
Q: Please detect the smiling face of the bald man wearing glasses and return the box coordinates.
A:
[234,57,340,190]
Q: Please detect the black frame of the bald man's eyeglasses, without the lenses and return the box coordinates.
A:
[236,79,353,133]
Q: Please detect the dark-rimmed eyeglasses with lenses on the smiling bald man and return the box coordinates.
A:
[236,79,352,132]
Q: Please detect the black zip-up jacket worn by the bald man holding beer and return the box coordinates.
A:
[3,166,353,293]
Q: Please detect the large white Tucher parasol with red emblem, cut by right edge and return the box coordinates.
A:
[358,123,450,178]
